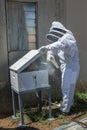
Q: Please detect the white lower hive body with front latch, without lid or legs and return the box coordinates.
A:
[10,70,49,93]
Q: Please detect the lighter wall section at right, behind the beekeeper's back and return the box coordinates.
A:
[66,0,87,81]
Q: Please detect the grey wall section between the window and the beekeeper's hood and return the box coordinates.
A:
[38,0,65,47]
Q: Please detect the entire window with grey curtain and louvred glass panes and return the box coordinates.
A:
[7,1,36,52]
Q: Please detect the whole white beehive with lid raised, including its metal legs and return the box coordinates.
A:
[10,50,52,127]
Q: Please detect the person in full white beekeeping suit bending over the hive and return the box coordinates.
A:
[39,21,80,115]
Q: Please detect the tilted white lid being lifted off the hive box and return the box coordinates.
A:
[9,50,42,73]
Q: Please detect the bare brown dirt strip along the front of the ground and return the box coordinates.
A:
[0,113,87,130]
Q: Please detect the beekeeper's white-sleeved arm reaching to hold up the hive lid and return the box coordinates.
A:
[45,33,77,57]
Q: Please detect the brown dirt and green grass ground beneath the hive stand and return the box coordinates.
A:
[0,98,87,130]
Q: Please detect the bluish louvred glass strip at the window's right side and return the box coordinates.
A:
[23,3,36,49]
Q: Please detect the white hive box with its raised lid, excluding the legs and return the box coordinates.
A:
[10,50,49,93]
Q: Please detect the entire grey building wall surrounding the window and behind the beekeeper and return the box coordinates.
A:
[0,0,87,112]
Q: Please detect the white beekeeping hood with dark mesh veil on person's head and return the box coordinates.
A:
[46,21,67,42]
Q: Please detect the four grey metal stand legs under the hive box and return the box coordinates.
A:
[12,88,54,128]
